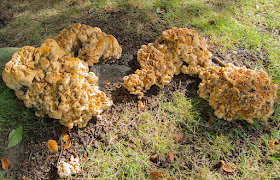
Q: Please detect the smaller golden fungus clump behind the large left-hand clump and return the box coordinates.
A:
[55,23,122,66]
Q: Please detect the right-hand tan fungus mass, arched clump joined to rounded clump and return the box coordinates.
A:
[123,28,278,123]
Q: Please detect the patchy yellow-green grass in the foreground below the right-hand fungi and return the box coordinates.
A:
[80,91,280,179]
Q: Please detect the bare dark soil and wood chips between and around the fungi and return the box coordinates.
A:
[0,7,276,179]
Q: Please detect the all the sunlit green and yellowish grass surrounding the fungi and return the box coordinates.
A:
[0,0,280,179]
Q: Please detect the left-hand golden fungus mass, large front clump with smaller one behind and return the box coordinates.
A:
[2,24,121,129]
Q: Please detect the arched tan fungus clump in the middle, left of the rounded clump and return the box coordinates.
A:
[123,28,211,99]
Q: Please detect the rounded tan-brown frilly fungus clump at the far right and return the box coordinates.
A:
[198,63,277,123]
